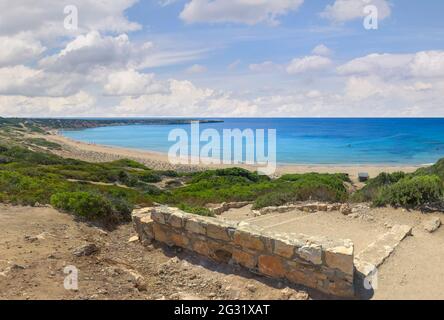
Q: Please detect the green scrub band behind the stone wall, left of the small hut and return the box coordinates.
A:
[0,146,347,222]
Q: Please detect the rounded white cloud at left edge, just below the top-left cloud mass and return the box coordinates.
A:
[0,35,46,67]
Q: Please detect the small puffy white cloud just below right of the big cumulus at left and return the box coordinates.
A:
[104,70,166,96]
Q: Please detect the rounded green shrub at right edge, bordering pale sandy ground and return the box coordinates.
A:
[373,175,443,208]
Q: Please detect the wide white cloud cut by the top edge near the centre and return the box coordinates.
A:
[180,0,304,25]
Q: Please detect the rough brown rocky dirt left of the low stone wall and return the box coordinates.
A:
[0,205,317,300]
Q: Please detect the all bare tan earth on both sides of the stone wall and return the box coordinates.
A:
[0,205,444,300]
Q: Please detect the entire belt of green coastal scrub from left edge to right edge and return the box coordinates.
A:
[0,118,444,223]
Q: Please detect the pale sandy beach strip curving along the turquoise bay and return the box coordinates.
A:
[40,130,425,181]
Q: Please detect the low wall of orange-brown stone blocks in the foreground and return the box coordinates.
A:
[133,207,354,297]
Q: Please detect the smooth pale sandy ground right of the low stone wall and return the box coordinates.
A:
[221,205,444,300]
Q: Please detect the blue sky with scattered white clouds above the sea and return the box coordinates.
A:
[0,0,444,117]
